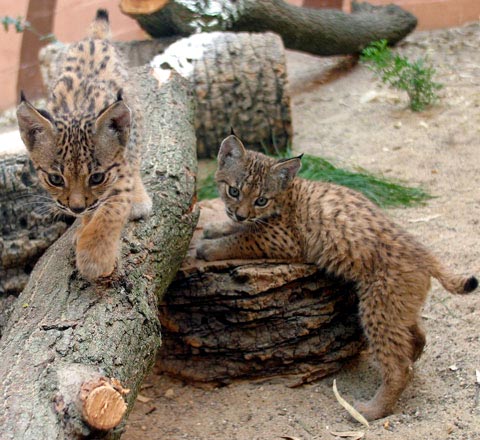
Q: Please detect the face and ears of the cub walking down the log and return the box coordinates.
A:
[18,95,130,216]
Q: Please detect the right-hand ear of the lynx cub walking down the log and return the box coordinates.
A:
[95,95,132,147]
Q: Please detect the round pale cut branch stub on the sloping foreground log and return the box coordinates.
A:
[80,377,130,431]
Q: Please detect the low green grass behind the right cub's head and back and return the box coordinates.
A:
[198,151,431,208]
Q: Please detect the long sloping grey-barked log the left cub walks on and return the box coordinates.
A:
[0,68,198,440]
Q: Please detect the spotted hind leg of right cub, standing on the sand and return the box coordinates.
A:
[355,282,425,420]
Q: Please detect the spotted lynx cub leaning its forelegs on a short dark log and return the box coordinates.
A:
[197,135,478,420]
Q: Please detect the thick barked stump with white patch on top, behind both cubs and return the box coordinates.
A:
[152,32,292,158]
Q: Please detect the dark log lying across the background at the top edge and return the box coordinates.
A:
[120,0,417,55]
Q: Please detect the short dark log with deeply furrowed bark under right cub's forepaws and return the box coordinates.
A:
[157,200,363,385]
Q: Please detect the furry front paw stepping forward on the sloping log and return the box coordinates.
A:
[76,236,118,281]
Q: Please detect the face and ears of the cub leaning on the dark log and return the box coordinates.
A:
[215,135,300,223]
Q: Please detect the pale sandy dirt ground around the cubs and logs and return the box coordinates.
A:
[122,24,480,440]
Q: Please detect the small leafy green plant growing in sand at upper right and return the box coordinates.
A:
[360,40,442,112]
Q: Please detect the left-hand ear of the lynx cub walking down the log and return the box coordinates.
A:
[17,92,56,151]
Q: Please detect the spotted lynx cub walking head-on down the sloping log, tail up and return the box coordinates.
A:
[17,9,152,280]
